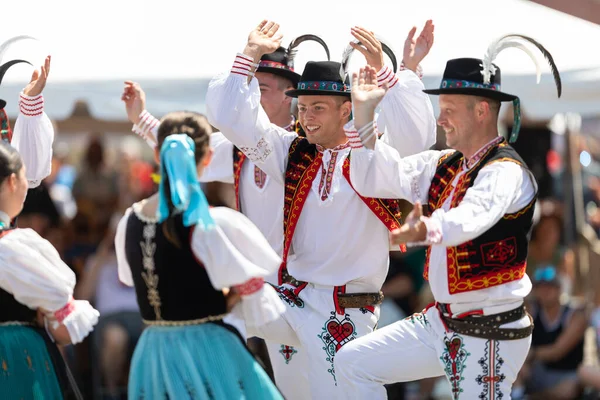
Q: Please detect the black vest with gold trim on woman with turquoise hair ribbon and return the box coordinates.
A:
[125,212,226,321]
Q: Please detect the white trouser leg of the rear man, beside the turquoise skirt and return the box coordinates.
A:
[265,340,310,400]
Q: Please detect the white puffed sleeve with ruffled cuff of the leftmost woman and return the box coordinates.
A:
[0,229,99,343]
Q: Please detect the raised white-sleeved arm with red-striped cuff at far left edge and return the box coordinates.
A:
[11,56,54,188]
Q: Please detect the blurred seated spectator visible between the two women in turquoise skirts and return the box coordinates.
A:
[76,214,144,400]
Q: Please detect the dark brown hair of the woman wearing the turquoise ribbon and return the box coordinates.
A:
[156,111,212,247]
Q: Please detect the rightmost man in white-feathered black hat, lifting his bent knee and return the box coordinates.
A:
[335,35,561,399]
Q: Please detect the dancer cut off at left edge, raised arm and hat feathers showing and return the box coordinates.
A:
[0,36,54,189]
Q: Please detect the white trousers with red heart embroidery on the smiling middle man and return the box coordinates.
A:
[248,284,379,399]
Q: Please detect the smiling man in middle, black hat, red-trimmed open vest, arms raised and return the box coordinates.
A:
[207,21,435,398]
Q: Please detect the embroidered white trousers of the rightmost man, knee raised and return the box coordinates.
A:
[335,307,531,400]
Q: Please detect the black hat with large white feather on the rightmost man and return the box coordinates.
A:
[424,34,562,143]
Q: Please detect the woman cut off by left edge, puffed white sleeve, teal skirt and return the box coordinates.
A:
[0,141,98,399]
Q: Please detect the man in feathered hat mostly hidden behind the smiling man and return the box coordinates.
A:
[122,34,330,400]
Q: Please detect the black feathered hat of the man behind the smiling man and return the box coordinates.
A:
[256,34,330,86]
